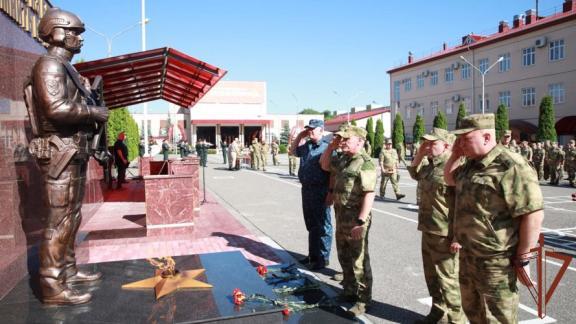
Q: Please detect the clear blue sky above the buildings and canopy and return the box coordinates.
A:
[51,0,563,113]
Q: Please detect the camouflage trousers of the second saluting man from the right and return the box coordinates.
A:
[422,232,466,323]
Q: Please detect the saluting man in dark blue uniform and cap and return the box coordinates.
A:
[290,119,332,270]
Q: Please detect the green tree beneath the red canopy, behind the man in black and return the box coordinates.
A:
[107,108,140,160]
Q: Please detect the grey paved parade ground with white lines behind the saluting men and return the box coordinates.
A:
[201,155,576,323]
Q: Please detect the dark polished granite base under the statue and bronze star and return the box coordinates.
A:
[0,252,283,324]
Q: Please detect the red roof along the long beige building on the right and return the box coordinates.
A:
[388,6,576,74]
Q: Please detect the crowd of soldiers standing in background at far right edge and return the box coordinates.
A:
[500,131,576,187]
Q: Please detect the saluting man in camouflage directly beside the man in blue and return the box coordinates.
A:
[330,126,377,316]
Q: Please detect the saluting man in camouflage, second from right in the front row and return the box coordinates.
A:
[408,128,466,323]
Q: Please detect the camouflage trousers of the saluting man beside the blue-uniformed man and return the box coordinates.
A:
[334,205,372,303]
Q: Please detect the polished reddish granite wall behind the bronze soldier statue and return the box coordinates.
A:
[0,13,103,298]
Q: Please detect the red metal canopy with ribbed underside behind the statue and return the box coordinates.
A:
[74,47,227,109]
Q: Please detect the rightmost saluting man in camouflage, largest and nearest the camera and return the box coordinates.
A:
[444,114,544,323]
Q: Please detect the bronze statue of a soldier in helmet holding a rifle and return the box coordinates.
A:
[24,8,108,305]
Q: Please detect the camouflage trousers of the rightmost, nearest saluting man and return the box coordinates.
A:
[460,251,519,324]
